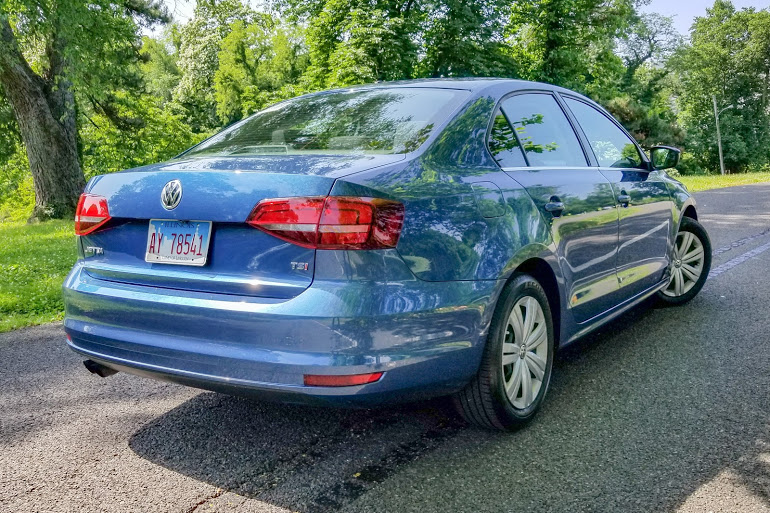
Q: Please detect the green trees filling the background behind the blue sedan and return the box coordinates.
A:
[0,0,770,218]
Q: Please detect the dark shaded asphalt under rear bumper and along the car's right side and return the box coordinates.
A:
[129,289,770,513]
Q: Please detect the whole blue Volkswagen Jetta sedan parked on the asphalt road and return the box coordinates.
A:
[64,79,711,429]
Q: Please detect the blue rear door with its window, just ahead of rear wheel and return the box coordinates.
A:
[490,92,619,322]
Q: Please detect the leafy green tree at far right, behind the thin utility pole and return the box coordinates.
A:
[672,0,770,172]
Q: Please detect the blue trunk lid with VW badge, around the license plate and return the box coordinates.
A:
[81,155,403,299]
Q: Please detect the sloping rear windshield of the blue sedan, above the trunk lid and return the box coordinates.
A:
[184,88,469,157]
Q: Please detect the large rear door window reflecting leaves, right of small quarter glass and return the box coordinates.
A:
[503,93,587,167]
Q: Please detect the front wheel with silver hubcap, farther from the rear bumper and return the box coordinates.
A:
[658,217,711,305]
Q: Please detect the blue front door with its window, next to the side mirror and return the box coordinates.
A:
[564,96,674,297]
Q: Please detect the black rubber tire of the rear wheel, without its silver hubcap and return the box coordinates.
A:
[454,274,554,430]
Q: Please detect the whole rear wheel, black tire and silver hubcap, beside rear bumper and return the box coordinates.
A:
[454,274,554,430]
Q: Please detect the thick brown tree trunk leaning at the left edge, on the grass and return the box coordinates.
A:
[0,17,85,220]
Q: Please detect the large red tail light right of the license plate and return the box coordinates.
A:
[246,196,404,249]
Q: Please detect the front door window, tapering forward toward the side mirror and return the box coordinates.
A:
[564,98,645,168]
